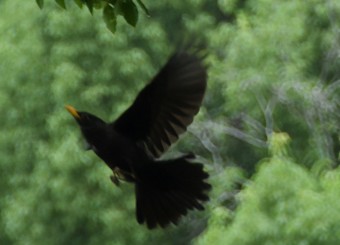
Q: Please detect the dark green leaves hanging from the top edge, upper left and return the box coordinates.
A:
[36,0,149,33]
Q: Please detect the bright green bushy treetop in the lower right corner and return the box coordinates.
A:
[197,135,340,245]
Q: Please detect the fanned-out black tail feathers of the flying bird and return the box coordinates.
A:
[136,154,211,229]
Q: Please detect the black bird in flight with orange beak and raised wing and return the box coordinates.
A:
[66,48,211,229]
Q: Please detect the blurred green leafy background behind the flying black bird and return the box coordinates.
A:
[0,0,340,245]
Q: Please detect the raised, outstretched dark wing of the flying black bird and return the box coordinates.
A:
[112,51,207,157]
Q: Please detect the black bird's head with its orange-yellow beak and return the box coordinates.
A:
[65,105,105,129]
